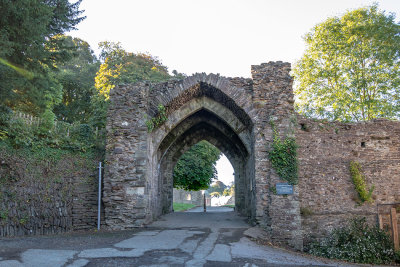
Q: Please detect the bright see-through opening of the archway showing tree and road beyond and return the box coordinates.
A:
[173,140,235,212]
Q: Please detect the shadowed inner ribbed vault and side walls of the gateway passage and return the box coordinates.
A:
[153,108,254,222]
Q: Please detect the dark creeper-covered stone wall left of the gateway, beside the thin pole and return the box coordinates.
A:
[0,146,98,239]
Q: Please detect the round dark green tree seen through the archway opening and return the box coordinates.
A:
[174,141,221,191]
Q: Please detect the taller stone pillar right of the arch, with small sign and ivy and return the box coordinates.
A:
[251,61,303,250]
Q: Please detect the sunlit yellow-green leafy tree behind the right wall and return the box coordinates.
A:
[293,5,400,121]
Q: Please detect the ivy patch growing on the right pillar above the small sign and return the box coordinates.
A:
[268,123,299,185]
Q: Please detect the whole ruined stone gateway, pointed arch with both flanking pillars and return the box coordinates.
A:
[103,62,302,251]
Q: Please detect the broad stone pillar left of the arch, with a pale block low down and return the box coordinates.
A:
[103,83,149,229]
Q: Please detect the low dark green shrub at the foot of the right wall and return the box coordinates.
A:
[309,218,394,264]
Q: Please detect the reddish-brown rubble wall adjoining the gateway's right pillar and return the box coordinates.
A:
[296,116,400,248]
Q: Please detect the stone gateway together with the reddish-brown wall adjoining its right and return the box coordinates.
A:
[103,62,400,249]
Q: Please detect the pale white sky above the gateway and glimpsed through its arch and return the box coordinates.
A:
[69,0,400,183]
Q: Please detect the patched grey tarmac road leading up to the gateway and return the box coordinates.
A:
[0,209,360,267]
